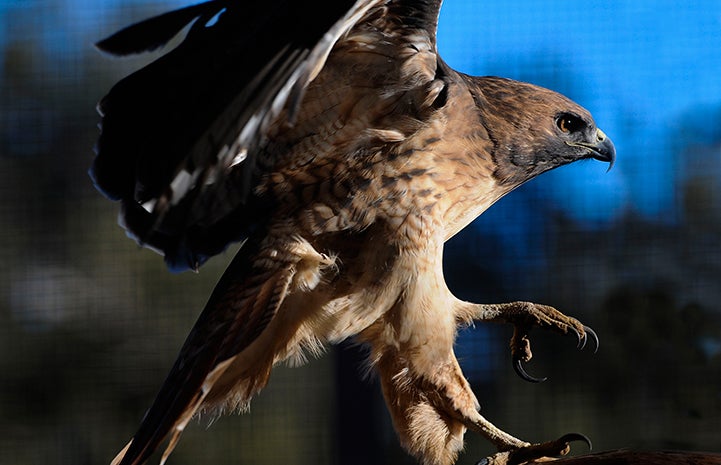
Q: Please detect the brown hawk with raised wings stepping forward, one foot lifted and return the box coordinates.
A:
[90,0,615,465]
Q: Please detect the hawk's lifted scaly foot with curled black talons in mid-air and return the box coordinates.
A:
[460,302,598,382]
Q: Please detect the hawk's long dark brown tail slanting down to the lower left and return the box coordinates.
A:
[111,239,295,465]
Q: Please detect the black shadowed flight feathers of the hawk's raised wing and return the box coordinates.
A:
[91,0,381,269]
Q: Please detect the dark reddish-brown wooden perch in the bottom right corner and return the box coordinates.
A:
[530,449,721,465]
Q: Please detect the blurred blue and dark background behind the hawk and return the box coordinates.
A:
[0,0,721,465]
